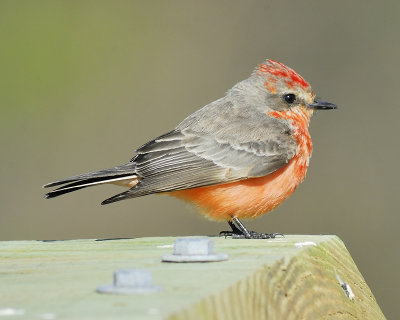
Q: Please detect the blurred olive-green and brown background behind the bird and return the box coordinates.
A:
[0,0,400,318]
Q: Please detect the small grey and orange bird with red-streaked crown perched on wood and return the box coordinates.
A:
[43,59,337,239]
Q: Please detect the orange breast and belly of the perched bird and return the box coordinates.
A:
[169,107,312,220]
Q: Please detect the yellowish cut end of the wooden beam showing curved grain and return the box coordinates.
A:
[168,237,385,320]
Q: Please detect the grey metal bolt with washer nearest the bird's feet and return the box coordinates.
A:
[162,237,228,262]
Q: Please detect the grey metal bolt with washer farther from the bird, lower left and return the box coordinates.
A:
[97,269,162,294]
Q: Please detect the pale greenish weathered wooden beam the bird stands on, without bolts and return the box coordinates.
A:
[0,235,384,320]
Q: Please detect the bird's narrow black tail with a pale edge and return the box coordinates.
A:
[43,162,137,199]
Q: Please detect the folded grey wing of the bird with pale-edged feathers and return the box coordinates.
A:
[105,102,297,203]
